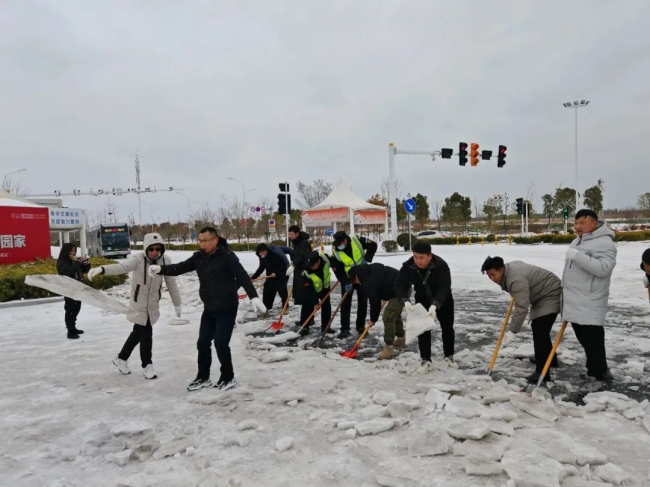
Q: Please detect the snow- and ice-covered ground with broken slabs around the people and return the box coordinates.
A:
[0,243,650,487]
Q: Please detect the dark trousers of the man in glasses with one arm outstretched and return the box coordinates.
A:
[196,307,237,382]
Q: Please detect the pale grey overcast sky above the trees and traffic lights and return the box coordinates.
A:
[0,0,650,221]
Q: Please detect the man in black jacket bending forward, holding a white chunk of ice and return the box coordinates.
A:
[395,242,456,372]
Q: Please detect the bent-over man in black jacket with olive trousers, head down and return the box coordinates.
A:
[349,263,406,360]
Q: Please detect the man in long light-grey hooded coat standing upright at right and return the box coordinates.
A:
[562,210,616,382]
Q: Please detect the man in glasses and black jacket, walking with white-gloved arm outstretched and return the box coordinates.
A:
[148,227,266,391]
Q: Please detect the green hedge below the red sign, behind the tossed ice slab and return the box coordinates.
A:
[0,257,128,303]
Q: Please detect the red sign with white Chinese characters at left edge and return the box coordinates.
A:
[0,206,51,265]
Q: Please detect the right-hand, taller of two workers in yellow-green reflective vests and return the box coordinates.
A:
[332,231,377,338]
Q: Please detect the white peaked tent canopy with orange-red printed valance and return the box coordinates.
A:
[302,181,388,235]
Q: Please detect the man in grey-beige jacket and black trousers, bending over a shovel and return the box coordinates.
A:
[481,257,562,383]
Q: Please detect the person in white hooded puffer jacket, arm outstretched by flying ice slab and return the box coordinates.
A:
[88,233,181,379]
